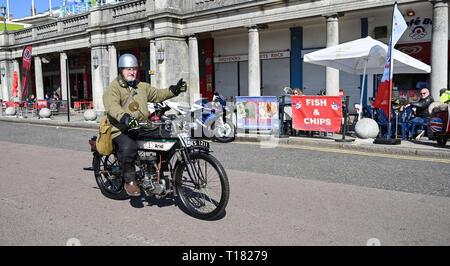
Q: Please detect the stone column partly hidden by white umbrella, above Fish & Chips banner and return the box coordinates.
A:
[325,14,339,96]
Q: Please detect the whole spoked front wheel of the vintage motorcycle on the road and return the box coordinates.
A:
[175,152,230,220]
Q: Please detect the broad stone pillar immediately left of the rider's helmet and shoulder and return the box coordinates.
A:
[91,46,110,115]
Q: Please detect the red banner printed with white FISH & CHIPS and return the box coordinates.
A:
[291,95,342,132]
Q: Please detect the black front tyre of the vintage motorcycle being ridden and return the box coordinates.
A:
[174,152,230,220]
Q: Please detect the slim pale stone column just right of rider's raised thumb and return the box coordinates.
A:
[188,36,200,106]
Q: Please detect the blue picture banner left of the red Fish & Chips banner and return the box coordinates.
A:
[236,96,280,130]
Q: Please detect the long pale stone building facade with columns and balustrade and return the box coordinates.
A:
[0,0,449,112]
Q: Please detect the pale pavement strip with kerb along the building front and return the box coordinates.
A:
[0,109,450,159]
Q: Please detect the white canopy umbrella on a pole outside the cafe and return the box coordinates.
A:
[303,37,431,118]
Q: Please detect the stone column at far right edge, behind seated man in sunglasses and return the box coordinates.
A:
[430,0,448,101]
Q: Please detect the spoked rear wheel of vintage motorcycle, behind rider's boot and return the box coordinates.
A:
[92,153,127,200]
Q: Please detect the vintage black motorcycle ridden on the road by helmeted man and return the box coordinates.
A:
[90,102,230,220]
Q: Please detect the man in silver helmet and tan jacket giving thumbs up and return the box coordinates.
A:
[103,54,187,196]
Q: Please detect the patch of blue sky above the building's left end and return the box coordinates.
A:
[0,0,80,18]
